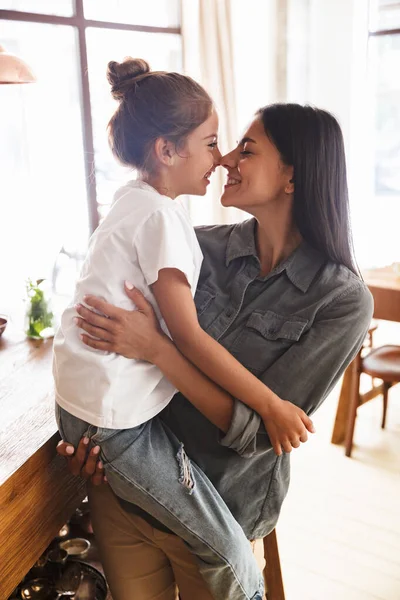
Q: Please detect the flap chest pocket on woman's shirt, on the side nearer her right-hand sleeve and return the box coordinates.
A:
[231,310,308,373]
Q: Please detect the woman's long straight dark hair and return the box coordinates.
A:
[257,104,359,275]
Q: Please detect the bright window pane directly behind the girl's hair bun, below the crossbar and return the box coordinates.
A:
[87,28,182,216]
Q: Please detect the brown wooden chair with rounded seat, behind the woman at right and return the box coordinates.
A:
[345,346,400,456]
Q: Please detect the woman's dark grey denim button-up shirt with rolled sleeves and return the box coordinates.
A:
[162,219,373,539]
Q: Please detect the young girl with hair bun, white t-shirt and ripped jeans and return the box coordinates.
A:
[54,59,313,600]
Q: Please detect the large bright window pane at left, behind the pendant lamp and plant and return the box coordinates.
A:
[0,21,88,324]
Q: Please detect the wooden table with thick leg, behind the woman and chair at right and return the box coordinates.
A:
[331,267,400,444]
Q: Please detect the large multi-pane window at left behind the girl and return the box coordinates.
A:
[0,0,182,321]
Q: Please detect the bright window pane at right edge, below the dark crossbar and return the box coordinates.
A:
[370,35,400,196]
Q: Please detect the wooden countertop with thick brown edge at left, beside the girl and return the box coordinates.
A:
[0,328,85,600]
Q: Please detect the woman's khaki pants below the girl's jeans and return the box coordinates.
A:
[88,484,263,600]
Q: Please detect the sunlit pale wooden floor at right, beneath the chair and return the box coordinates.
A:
[260,326,400,600]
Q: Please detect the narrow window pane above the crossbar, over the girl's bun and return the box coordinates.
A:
[84,0,180,27]
